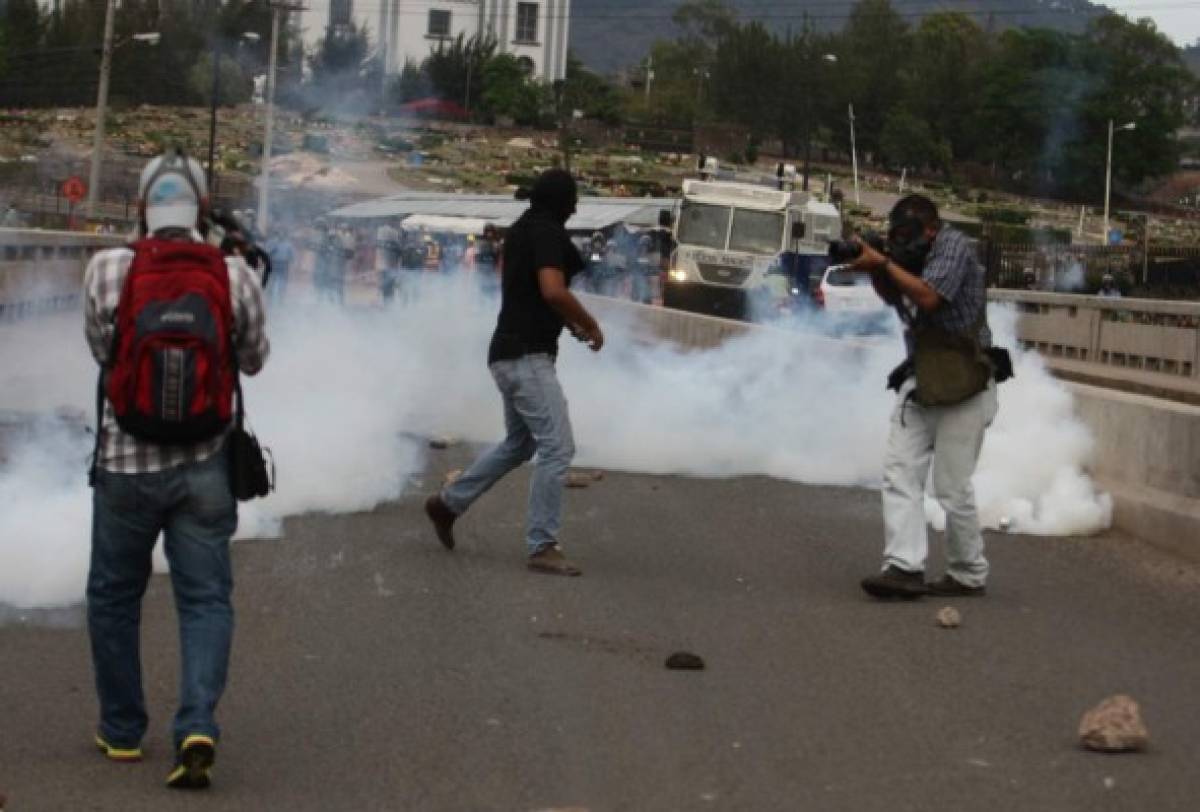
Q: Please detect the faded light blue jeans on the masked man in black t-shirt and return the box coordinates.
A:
[442,354,575,554]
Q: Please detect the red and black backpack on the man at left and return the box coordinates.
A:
[104,239,238,444]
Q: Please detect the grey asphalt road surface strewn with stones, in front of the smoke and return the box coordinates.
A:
[0,447,1200,812]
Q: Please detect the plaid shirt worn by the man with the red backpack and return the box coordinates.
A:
[83,237,270,474]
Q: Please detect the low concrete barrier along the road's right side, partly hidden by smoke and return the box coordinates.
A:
[583,296,1200,560]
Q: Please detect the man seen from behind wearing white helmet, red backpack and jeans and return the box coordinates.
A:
[84,152,269,789]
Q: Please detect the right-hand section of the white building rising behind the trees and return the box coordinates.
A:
[371,0,571,82]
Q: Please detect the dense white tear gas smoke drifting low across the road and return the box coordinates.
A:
[0,275,1111,607]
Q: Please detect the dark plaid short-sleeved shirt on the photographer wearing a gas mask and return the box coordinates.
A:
[908,225,991,351]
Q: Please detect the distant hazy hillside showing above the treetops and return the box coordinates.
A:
[571,0,1103,73]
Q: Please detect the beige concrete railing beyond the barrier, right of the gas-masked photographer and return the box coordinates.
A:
[989,290,1200,378]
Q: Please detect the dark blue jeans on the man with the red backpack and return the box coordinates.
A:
[88,451,238,748]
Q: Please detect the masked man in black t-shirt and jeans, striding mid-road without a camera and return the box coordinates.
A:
[425,169,604,576]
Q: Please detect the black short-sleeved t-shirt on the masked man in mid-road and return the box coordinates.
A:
[487,209,583,363]
